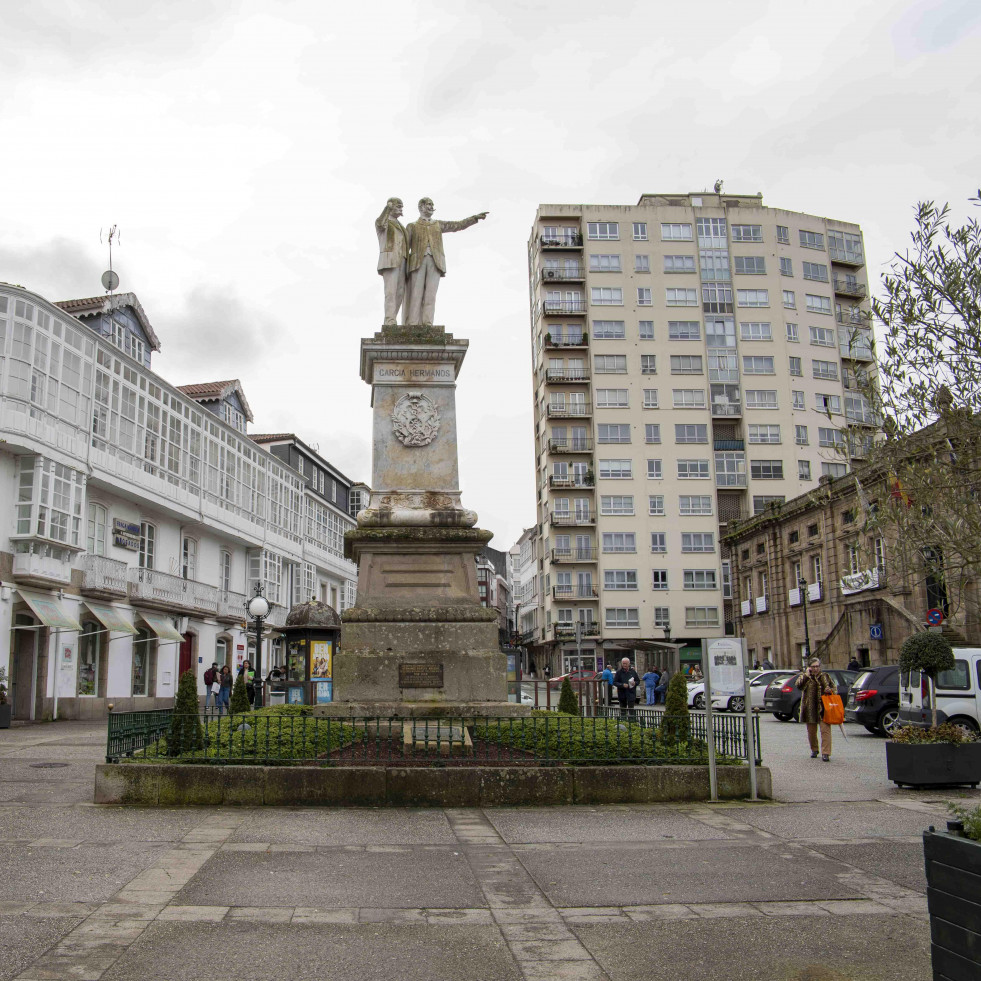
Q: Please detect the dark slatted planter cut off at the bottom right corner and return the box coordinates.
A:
[923,831,981,981]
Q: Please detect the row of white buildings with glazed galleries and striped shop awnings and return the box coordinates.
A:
[0,283,356,719]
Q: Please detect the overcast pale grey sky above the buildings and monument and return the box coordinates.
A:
[0,0,981,549]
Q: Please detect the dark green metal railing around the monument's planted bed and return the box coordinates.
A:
[106,707,759,767]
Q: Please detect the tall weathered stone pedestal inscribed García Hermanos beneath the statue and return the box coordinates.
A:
[334,327,522,717]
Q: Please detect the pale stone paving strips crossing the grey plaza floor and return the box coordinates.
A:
[0,805,926,981]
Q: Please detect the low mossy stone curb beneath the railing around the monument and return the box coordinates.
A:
[95,763,773,807]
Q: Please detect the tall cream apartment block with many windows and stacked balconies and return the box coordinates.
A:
[528,192,874,673]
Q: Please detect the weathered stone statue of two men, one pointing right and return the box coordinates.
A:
[375,198,487,326]
